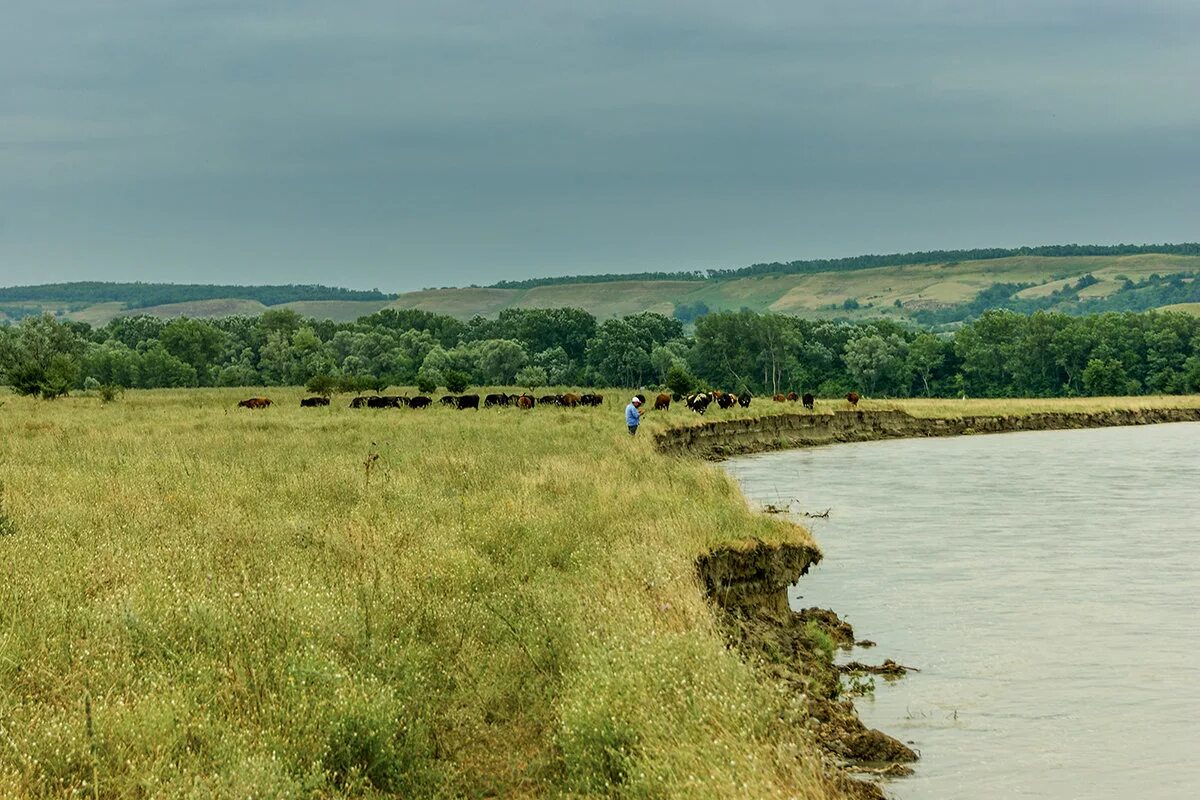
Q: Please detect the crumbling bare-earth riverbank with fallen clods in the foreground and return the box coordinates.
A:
[697,542,917,798]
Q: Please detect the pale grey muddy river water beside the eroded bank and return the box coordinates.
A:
[725,423,1200,800]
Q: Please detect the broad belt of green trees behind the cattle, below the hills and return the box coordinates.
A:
[0,303,1200,397]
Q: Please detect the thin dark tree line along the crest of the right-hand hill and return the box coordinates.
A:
[491,242,1200,289]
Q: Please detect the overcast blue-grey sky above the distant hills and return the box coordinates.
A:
[0,0,1200,291]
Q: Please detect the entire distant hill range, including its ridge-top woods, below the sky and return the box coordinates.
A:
[0,243,1200,325]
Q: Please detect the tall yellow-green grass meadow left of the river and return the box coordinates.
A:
[0,390,828,798]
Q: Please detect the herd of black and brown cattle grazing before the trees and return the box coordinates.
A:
[238,390,862,414]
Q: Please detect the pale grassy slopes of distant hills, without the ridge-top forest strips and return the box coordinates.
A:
[7,253,1200,325]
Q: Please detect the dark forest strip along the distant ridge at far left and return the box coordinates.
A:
[0,281,396,308]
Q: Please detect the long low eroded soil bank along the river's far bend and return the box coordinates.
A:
[654,408,1200,461]
